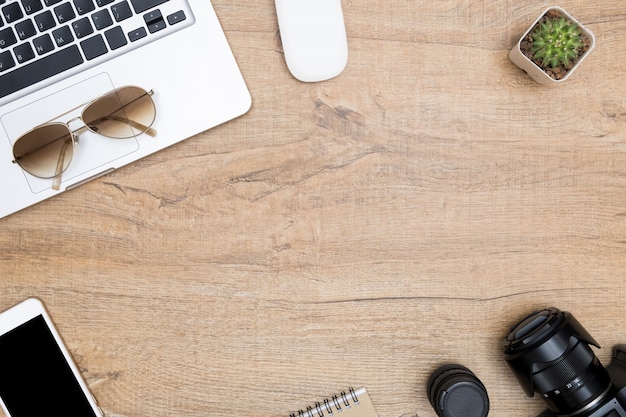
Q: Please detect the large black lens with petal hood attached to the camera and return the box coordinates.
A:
[503,307,612,417]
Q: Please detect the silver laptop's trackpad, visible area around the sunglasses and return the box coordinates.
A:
[0,73,139,193]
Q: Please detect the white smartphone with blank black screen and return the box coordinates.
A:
[0,298,103,417]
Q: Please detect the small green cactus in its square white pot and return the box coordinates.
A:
[509,6,595,84]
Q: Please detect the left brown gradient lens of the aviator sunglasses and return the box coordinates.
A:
[13,123,74,178]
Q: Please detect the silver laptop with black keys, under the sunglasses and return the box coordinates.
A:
[0,0,251,218]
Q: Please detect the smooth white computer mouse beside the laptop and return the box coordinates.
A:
[275,0,348,82]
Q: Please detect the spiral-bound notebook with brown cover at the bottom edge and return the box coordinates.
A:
[290,388,378,417]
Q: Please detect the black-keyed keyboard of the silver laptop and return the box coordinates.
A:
[0,0,192,99]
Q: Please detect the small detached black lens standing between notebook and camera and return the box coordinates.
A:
[427,364,489,417]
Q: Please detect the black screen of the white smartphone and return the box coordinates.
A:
[0,315,97,417]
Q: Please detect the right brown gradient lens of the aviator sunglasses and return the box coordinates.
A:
[82,87,156,139]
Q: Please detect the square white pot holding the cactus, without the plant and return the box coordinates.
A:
[509,6,596,84]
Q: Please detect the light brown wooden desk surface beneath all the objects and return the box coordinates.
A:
[0,0,626,417]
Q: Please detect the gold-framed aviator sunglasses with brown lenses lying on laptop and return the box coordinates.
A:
[13,86,156,190]
